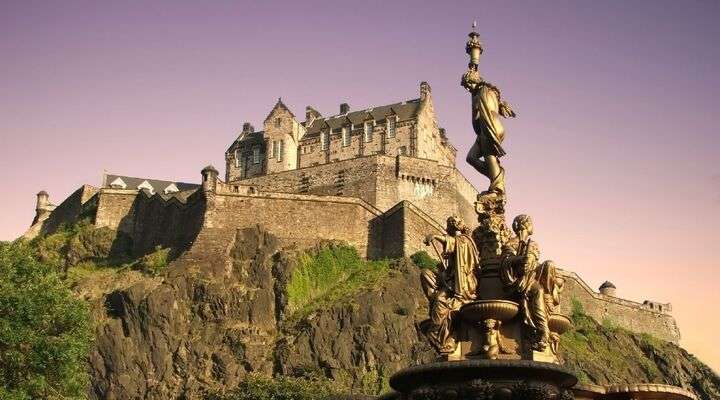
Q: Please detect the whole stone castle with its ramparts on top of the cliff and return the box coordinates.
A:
[24,82,680,342]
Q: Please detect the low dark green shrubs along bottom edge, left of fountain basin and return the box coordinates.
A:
[207,375,340,400]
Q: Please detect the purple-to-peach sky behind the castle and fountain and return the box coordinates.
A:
[0,0,720,370]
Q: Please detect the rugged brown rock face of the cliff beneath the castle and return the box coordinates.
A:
[90,228,720,399]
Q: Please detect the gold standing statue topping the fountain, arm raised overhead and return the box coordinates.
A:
[461,25,515,196]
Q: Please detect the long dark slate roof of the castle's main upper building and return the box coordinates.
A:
[303,99,420,139]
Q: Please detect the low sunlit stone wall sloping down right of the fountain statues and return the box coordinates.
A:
[560,271,680,343]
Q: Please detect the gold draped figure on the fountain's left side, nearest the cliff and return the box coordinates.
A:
[421,216,480,355]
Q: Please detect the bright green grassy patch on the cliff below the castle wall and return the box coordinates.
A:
[287,244,390,317]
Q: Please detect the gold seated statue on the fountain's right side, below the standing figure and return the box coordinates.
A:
[500,215,562,351]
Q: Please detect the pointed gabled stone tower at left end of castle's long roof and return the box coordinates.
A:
[263,99,305,174]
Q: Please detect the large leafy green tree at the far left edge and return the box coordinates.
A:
[0,236,92,400]
